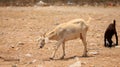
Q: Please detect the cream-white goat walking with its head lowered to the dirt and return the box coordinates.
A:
[39,19,88,59]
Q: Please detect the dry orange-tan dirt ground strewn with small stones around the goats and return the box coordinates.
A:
[0,6,120,67]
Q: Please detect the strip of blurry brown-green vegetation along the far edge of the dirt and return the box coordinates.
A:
[0,0,120,6]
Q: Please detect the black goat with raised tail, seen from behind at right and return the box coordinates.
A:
[104,20,118,47]
